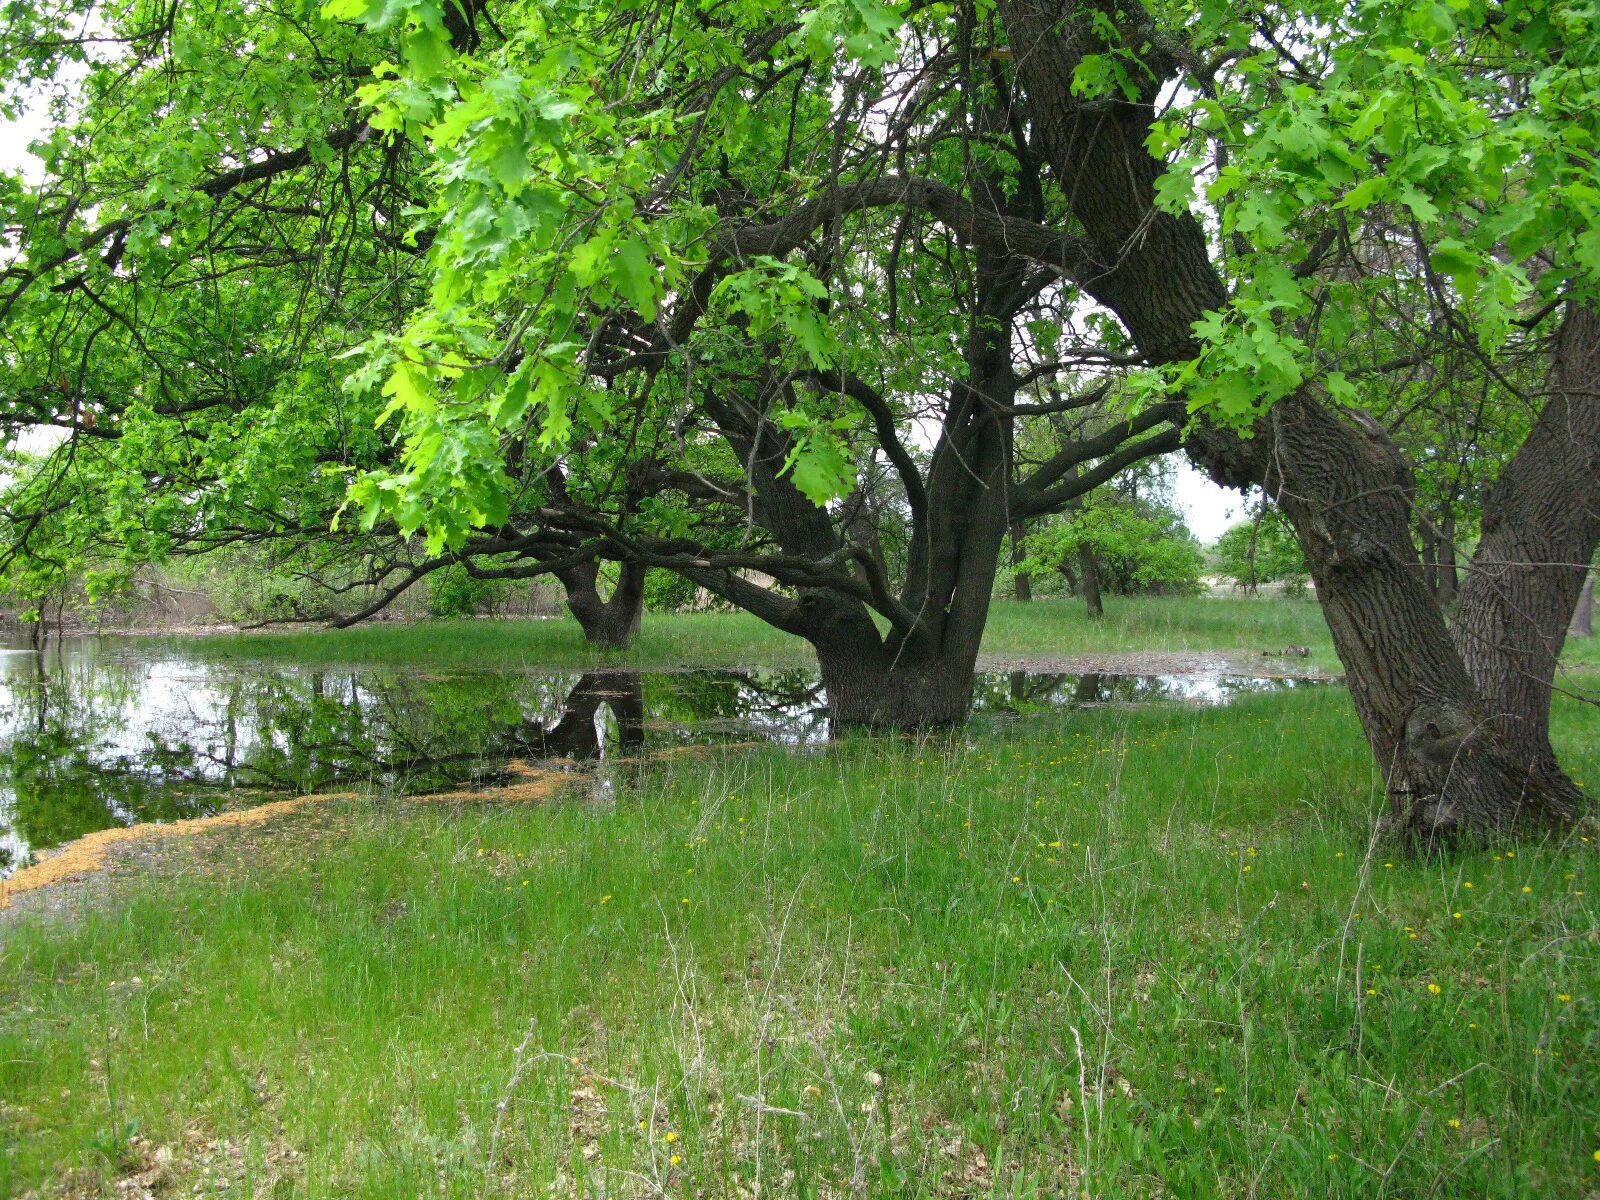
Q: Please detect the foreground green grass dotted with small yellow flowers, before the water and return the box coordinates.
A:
[0,691,1600,1198]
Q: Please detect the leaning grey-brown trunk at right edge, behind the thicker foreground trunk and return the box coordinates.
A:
[1454,302,1600,806]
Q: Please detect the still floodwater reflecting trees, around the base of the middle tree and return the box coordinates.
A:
[0,638,1324,874]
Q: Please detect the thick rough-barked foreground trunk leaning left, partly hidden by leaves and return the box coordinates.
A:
[1000,0,1571,842]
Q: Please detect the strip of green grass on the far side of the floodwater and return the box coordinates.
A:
[162,597,1336,669]
